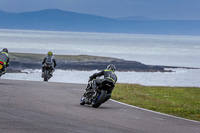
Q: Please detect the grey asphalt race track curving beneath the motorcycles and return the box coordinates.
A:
[0,79,200,133]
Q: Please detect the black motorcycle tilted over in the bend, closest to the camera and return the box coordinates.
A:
[80,80,114,108]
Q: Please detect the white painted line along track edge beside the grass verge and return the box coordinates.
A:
[110,99,200,124]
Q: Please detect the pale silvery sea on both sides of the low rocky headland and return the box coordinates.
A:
[0,29,200,87]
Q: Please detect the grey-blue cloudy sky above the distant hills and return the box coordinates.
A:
[0,0,200,20]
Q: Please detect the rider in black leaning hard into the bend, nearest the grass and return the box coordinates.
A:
[86,64,117,102]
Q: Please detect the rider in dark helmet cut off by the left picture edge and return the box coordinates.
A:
[0,48,10,74]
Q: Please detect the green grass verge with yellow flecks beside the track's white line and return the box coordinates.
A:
[112,84,200,121]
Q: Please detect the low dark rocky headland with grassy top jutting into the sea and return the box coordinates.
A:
[7,53,196,72]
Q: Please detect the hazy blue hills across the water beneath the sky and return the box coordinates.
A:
[0,9,200,35]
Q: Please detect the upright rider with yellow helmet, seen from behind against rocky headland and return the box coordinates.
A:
[42,51,57,77]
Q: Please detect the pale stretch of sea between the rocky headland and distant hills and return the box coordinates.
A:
[0,29,200,68]
